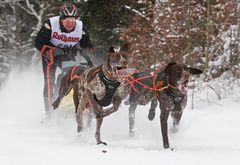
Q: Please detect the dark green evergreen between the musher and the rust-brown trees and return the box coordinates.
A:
[78,0,132,48]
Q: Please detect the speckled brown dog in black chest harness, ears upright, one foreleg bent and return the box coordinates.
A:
[76,45,128,144]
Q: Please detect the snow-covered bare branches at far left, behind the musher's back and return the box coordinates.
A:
[0,0,47,85]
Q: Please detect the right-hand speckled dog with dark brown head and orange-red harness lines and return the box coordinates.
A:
[125,62,202,148]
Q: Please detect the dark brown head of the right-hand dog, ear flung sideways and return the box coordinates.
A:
[164,62,203,95]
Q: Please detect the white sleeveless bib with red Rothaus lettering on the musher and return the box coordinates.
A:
[49,16,82,48]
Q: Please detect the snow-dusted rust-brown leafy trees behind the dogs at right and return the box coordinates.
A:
[122,0,239,80]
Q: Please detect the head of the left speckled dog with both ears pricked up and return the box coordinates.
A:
[107,44,129,80]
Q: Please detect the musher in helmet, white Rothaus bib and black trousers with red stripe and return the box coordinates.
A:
[35,3,93,115]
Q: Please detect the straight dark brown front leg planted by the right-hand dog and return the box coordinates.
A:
[160,107,170,149]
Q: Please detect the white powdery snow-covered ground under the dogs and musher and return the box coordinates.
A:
[0,65,240,165]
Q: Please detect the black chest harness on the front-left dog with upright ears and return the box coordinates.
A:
[94,67,121,106]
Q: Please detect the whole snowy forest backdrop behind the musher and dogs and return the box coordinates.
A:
[0,0,240,97]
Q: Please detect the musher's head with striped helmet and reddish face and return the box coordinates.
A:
[59,3,78,31]
